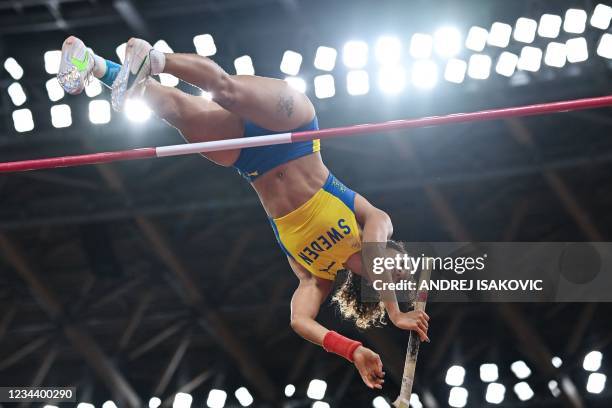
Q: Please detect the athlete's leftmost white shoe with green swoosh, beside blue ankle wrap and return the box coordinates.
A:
[57,36,94,95]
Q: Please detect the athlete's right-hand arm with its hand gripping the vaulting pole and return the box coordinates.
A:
[355,194,429,341]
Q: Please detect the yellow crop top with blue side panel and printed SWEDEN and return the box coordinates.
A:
[270,173,361,280]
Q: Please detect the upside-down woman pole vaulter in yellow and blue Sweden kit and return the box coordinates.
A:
[58,37,429,388]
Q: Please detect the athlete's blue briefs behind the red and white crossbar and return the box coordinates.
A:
[234,116,321,181]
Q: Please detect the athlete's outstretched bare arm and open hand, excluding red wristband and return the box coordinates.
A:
[288,258,385,389]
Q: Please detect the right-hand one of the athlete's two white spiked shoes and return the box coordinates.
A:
[112,38,153,111]
